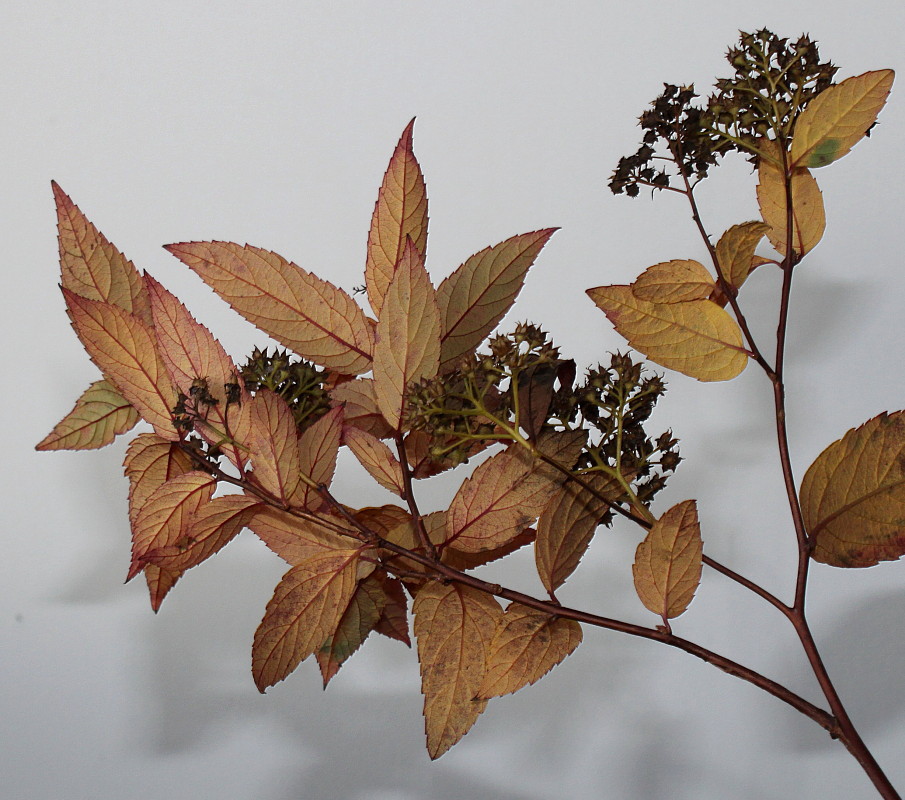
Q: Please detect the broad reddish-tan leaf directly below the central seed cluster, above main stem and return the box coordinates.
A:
[447,445,557,553]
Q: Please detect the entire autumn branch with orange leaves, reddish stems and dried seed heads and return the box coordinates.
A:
[38,31,905,797]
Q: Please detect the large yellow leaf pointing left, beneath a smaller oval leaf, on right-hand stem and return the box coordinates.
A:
[587,286,748,381]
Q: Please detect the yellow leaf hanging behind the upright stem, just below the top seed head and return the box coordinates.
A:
[757,142,826,256]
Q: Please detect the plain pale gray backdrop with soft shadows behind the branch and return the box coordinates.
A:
[7,0,905,800]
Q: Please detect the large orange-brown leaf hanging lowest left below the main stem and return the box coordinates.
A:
[251,549,361,692]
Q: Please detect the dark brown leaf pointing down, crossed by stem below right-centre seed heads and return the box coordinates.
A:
[534,475,621,592]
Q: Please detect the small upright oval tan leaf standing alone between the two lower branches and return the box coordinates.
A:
[632,500,703,621]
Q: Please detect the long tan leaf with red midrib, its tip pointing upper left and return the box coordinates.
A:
[166,242,374,375]
